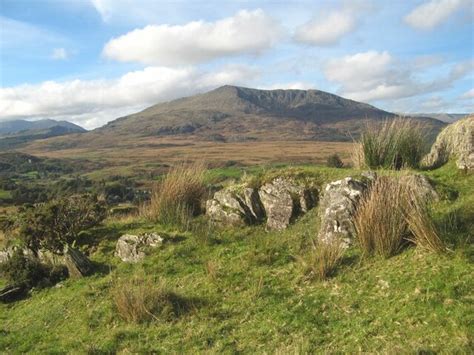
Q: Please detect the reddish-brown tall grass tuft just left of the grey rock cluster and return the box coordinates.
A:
[147,163,206,226]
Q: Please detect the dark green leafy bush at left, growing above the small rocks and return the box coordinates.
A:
[18,196,106,252]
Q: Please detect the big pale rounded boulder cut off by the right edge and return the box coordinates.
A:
[423,115,474,170]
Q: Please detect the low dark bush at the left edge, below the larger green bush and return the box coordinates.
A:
[0,250,67,288]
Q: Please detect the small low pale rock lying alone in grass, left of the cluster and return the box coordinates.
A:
[115,233,163,263]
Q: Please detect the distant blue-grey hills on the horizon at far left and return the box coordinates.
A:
[0,119,86,137]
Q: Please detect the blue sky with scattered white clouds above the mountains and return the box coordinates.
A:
[0,0,474,129]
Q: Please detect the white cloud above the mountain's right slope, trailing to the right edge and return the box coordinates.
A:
[323,51,474,101]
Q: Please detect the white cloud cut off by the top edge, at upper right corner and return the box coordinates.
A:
[404,0,466,30]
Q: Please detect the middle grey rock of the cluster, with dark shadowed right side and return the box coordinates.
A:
[258,178,318,230]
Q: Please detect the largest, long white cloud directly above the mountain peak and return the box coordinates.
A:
[103,9,280,66]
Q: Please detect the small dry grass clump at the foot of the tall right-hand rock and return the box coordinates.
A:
[299,241,345,280]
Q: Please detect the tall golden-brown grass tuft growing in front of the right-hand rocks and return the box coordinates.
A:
[354,177,408,257]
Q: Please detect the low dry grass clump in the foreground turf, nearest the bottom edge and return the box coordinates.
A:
[111,277,185,323]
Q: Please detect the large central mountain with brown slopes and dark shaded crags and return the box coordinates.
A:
[99,85,444,141]
